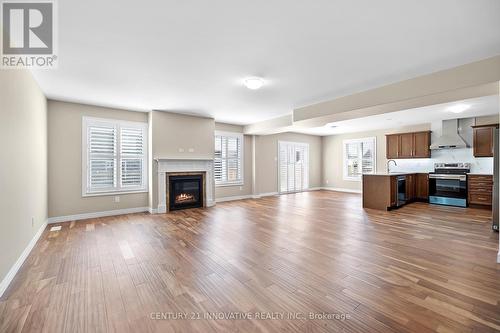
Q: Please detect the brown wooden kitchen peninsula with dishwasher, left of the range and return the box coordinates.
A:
[363,172,429,210]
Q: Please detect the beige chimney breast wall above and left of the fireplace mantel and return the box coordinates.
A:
[149,111,215,208]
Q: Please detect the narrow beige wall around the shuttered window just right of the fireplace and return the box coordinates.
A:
[215,123,253,200]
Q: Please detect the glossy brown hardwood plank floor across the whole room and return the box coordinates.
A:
[0,191,500,333]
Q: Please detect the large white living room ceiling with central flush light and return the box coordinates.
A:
[34,0,500,124]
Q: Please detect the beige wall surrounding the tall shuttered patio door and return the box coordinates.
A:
[255,133,322,194]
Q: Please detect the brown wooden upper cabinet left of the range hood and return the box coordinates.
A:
[386,131,431,159]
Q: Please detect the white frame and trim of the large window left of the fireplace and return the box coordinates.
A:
[81,116,149,197]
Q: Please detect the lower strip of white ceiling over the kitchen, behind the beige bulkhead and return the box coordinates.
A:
[287,95,500,135]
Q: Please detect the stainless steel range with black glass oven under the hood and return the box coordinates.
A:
[429,163,470,207]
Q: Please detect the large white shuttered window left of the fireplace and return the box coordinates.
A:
[82,117,148,196]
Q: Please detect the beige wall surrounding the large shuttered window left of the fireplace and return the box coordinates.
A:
[48,101,148,217]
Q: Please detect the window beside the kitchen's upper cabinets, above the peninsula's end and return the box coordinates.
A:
[343,138,377,180]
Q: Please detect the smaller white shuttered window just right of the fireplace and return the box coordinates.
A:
[214,132,243,186]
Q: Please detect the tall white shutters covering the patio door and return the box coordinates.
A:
[278,141,309,193]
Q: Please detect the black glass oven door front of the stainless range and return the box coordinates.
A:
[429,174,467,207]
